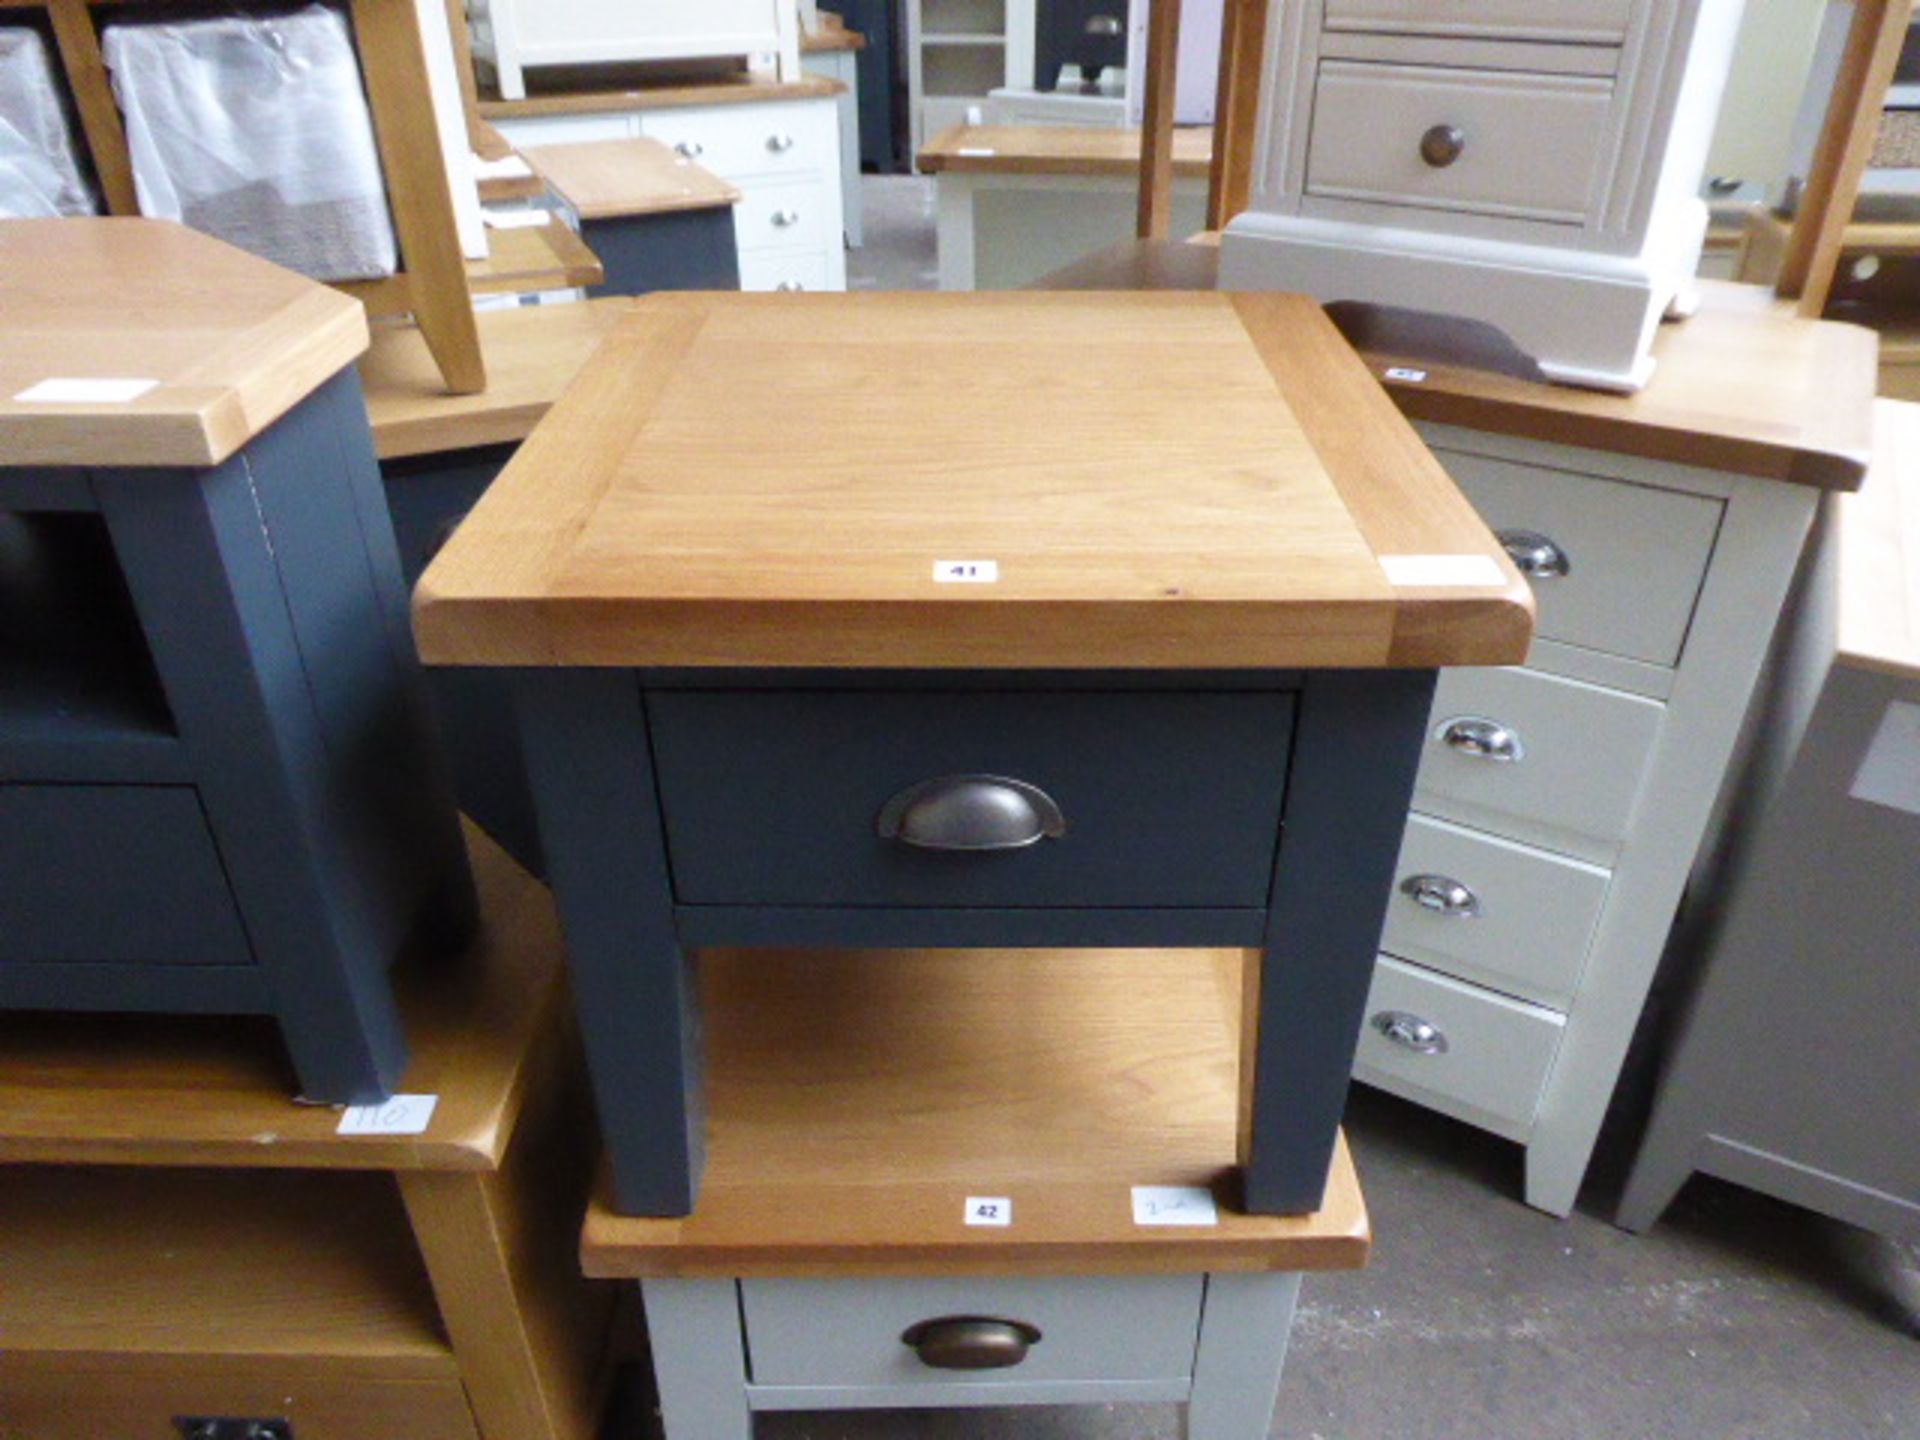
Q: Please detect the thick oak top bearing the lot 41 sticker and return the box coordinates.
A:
[415,294,1532,670]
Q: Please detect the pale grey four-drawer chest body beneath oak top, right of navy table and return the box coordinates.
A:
[1346,426,1816,1213]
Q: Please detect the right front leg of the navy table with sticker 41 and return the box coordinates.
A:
[1244,670,1434,1215]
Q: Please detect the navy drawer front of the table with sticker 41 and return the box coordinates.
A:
[647,691,1292,906]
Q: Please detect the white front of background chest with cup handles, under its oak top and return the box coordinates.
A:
[497,96,847,290]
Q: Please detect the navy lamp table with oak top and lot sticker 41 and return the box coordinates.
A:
[415,294,1532,1215]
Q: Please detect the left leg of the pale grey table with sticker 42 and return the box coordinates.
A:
[639,1281,753,1440]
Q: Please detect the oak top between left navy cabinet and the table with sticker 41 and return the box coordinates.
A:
[361,296,634,459]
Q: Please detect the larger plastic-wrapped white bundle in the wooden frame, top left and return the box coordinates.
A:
[102,6,397,280]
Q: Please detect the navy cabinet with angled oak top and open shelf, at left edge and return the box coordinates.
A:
[0,221,472,1102]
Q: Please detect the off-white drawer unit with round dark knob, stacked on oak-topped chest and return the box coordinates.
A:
[1221,0,1741,390]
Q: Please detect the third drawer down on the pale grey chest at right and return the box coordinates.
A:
[1380,814,1609,1006]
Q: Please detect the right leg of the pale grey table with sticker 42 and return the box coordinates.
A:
[1187,1275,1300,1440]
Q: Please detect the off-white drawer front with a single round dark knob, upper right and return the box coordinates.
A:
[1306,60,1613,225]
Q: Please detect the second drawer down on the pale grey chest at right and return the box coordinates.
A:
[1415,668,1667,864]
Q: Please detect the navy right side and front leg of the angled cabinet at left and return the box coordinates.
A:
[94,401,441,1102]
